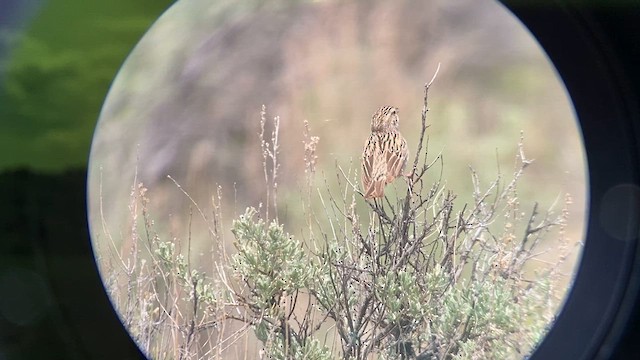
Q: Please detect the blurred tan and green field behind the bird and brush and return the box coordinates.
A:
[89,0,587,354]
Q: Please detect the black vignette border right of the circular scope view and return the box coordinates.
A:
[502,0,640,359]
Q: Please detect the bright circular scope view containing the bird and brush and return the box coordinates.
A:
[88,0,587,359]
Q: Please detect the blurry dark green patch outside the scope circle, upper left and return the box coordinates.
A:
[0,0,172,171]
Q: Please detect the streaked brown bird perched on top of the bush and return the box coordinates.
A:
[362,106,409,199]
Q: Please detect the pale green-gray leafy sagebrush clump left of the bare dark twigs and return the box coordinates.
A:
[231,208,331,359]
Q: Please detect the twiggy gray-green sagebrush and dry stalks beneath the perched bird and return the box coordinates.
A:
[94,71,571,360]
